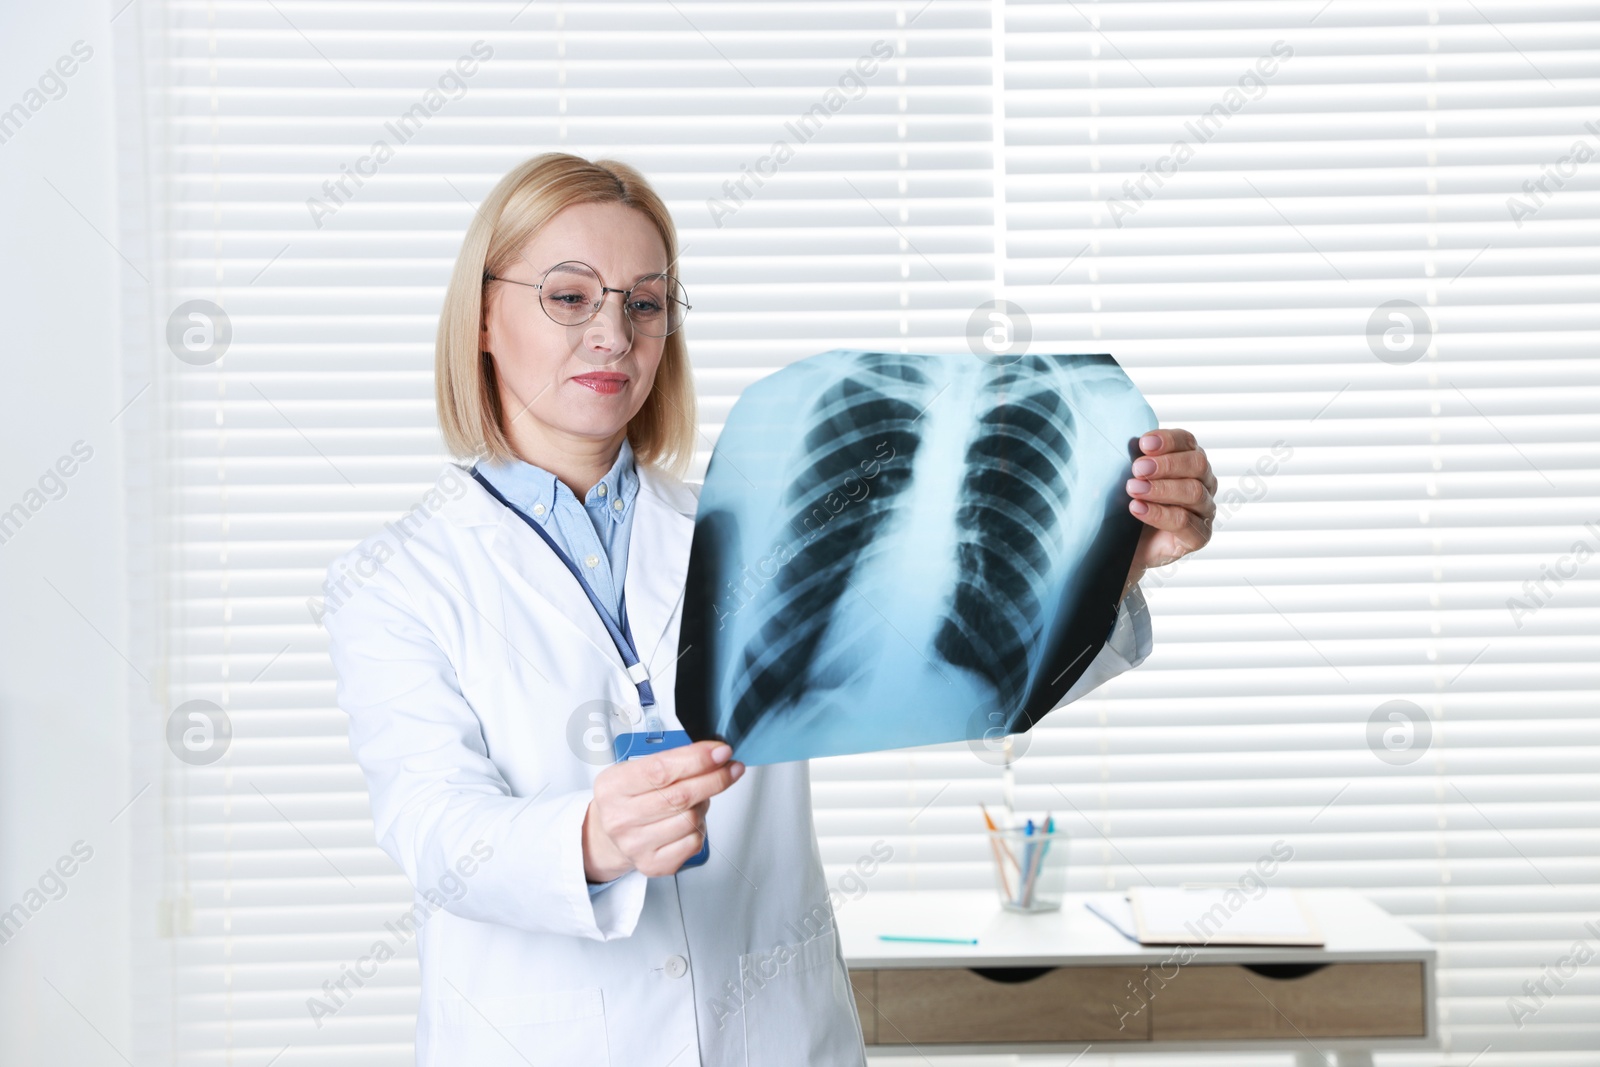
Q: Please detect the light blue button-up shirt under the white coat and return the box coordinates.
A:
[478,437,638,896]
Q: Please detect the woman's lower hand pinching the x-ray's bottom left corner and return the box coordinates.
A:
[584,741,744,881]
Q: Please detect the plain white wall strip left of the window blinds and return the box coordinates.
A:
[0,0,132,1067]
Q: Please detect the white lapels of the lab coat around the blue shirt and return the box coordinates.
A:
[443,462,698,699]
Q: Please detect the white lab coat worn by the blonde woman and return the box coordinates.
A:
[323,464,1150,1067]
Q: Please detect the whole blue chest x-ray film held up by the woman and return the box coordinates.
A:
[675,349,1155,765]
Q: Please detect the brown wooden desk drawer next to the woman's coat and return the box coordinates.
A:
[850,966,1150,1045]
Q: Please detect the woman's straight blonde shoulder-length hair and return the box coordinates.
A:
[434,152,696,477]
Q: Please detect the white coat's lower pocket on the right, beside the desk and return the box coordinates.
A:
[739,933,864,1067]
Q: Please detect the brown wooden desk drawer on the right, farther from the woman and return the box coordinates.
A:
[1150,963,1427,1041]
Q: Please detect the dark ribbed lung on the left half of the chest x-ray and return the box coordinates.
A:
[733,354,933,748]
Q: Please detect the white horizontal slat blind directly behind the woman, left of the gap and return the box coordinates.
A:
[144,0,998,1065]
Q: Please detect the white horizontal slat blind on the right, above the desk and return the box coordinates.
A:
[992,0,1600,1065]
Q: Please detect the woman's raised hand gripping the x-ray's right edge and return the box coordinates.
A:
[1122,430,1216,595]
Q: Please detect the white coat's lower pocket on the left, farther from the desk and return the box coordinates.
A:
[418,985,611,1067]
